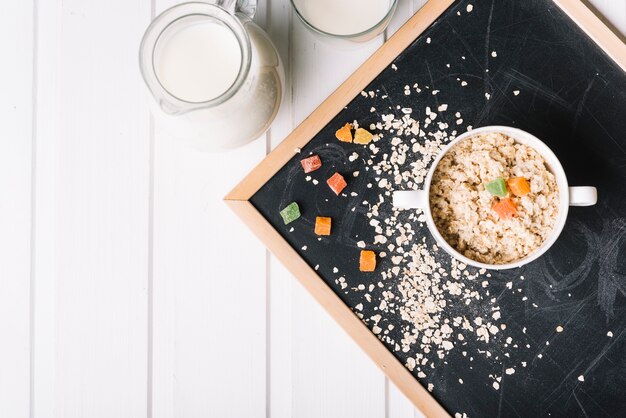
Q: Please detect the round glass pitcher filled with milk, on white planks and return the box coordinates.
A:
[139,0,284,151]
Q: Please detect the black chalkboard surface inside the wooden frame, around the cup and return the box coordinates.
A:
[251,0,626,417]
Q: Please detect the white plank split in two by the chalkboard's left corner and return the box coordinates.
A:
[269,1,392,417]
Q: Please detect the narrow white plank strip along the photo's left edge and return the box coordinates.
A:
[0,0,34,418]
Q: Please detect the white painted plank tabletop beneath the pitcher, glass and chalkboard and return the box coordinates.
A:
[0,0,626,418]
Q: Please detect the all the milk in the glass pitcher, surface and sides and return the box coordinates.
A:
[145,18,284,151]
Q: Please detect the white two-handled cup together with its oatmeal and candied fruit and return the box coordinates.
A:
[393,126,597,270]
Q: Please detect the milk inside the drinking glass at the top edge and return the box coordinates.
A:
[294,0,392,35]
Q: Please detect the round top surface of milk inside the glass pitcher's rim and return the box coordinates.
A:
[154,19,242,103]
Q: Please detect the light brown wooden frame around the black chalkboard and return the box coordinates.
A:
[224,0,626,417]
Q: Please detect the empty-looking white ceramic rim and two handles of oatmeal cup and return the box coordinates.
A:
[393,126,598,270]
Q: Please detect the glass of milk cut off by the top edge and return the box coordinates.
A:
[291,0,398,42]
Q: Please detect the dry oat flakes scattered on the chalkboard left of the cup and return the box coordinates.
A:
[332,103,521,396]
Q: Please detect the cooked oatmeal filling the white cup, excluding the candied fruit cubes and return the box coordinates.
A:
[430,133,559,264]
